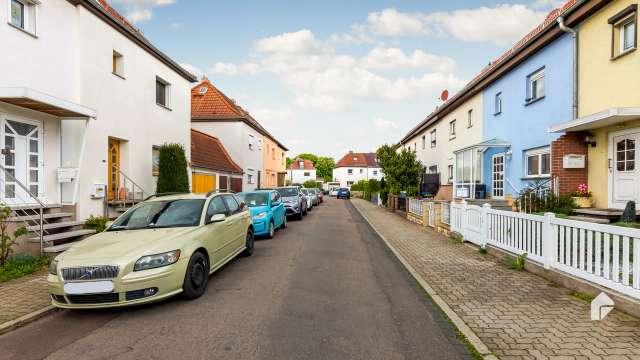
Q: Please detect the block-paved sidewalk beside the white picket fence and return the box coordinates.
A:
[352,199,640,359]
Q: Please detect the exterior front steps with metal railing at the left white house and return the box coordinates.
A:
[7,204,95,254]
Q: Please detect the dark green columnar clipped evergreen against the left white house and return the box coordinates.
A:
[156,144,189,193]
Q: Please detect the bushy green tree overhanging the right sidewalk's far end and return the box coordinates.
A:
[376,145,424,195]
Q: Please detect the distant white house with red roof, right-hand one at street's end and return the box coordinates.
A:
[333,151,384,187]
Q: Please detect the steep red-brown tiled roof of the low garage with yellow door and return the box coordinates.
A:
[191,129,242,174]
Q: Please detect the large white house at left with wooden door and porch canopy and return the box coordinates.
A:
[0,0,195,252]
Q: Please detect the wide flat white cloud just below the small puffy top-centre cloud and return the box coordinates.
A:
[360,46,456,72]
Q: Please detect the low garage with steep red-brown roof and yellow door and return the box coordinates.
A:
[191,130,242,193]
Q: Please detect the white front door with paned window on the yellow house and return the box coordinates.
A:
[609,132,640,209]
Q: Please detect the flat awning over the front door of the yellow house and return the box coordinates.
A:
[549,107,640,133]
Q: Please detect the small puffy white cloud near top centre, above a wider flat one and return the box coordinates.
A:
[367,9,427,36]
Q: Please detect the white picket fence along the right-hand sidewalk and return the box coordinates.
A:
[451,202,640,299]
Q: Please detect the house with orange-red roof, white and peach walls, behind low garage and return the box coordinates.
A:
[191,78,287,191]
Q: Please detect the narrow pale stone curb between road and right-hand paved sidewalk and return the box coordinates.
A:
[353,200,498,360]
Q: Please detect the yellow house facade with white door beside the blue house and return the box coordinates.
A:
[550,0,640,209]
